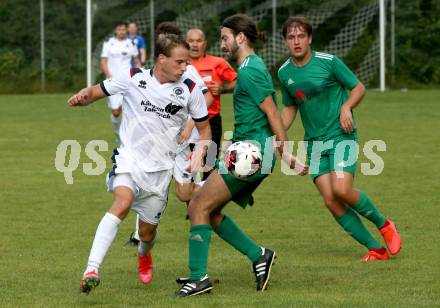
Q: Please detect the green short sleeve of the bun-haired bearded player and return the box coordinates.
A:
[237,67,275,105]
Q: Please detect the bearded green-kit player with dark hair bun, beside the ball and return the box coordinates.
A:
[177,15,307,297]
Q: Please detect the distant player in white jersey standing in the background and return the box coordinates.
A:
[101,22,141,142]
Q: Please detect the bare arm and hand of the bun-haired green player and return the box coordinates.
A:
[260,95,308,175]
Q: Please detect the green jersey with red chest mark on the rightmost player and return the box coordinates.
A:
[278,51,359,140]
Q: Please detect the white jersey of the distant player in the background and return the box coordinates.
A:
[101,37,137,76]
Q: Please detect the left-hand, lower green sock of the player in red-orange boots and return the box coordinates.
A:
[336,207,382,250]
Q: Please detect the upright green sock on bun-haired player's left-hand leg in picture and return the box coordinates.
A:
[188,225,212,280]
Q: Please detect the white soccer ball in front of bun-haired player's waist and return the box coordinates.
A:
[223,141,262,178]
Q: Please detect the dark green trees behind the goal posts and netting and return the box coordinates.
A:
[0,0,440,93]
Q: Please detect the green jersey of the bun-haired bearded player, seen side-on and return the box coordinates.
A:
[233,54,276,150]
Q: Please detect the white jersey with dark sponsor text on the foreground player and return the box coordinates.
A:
[101,68,208,173]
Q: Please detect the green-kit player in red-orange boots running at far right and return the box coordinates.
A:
[278,16,401,261]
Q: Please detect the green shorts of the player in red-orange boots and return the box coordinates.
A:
[307,133,359,182]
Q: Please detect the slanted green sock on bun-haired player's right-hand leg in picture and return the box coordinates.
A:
[215,216,262,263]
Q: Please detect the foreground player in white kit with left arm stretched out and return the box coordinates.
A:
[68,35,211,293]
